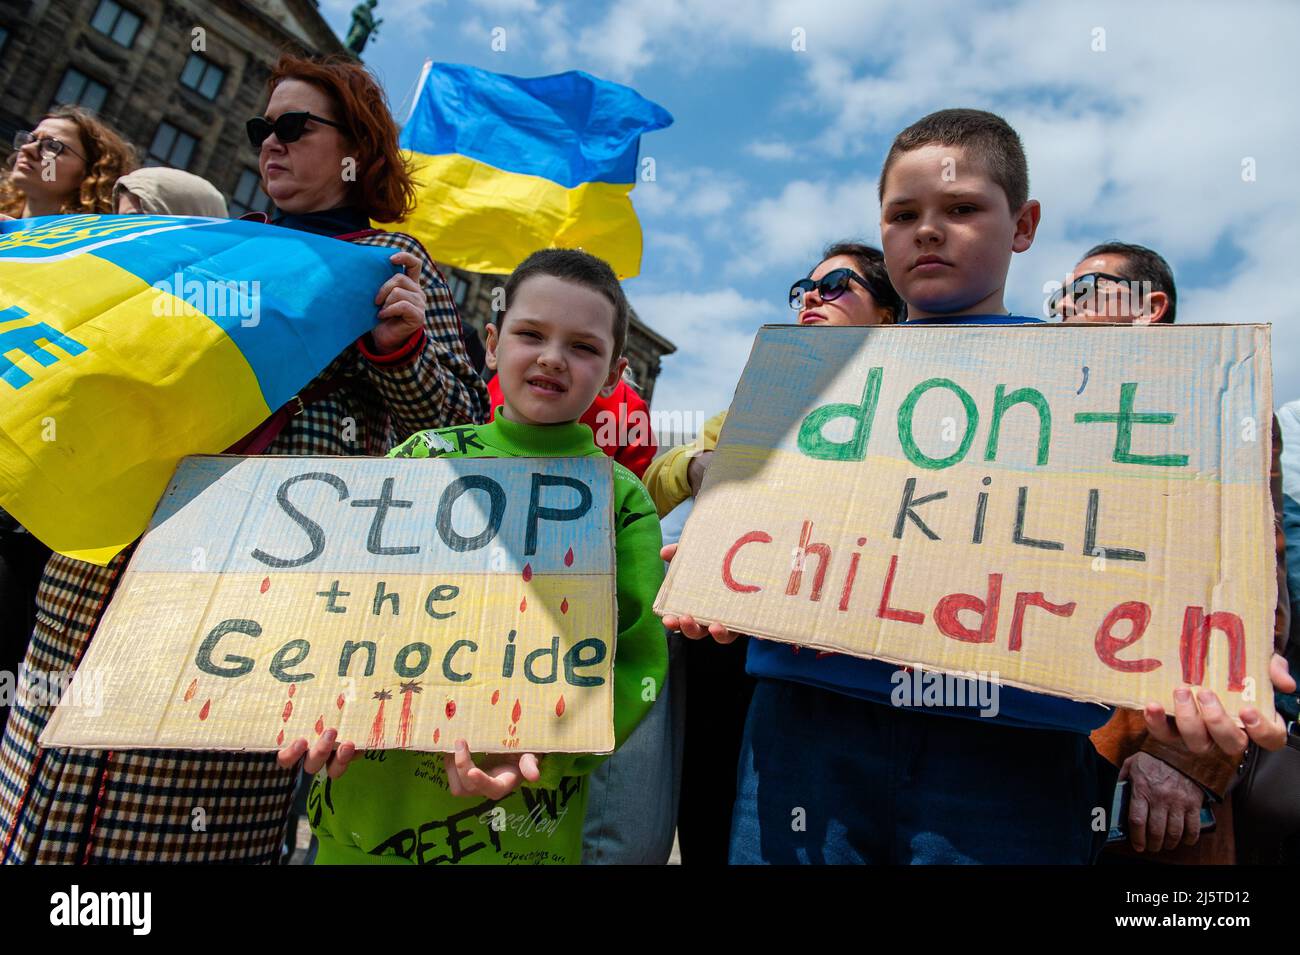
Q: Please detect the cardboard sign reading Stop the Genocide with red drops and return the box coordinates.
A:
[42,456,616,752]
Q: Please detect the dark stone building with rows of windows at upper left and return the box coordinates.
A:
[0,0,343,216]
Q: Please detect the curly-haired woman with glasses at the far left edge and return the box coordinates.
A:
[0,107,137,218]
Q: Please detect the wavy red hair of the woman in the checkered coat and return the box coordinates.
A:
[267,53,416,222]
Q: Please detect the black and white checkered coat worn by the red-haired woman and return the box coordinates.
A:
[0,233,488,863]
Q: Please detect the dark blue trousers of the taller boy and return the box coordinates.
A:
[731,680,1097,864]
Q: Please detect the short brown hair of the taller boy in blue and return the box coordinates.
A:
[878,109,1030,214]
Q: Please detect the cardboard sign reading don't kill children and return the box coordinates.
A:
[655,325,1277,715]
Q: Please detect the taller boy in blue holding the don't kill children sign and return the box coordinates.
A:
[664,109,1110,863]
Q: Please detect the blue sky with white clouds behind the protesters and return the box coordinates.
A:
[321,0,1300,414]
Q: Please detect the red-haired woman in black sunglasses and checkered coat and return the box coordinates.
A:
[0,56,488,863]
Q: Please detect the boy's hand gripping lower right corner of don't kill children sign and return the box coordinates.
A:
[1143,654,1296,759]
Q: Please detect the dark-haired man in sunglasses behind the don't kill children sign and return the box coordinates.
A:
[1048,242,1178,325]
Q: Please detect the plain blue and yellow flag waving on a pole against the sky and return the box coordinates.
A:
[387,62,672,278]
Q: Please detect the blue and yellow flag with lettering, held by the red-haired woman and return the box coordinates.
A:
[0,216,394,564]
